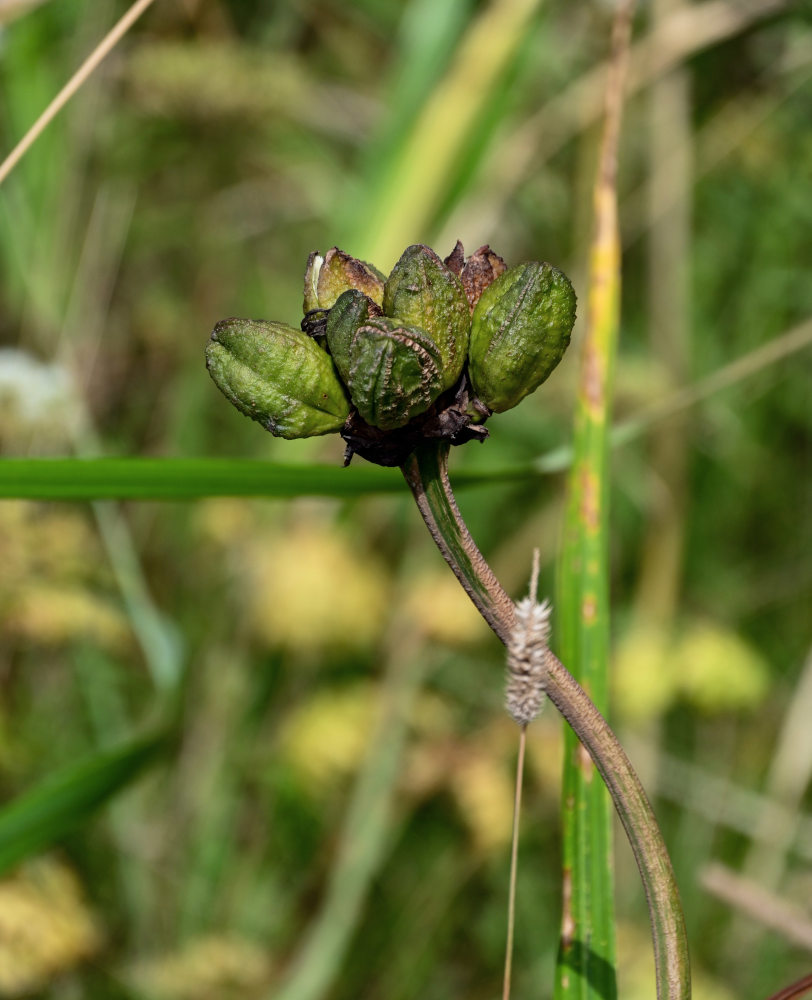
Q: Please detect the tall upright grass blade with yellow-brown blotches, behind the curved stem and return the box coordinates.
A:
[555,2,633,1000]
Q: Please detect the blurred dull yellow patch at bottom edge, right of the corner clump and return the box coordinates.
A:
[131,935,271,1000]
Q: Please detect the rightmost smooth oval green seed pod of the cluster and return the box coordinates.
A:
[468,261,575,413]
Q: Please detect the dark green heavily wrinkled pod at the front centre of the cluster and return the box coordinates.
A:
[327,316,443,431]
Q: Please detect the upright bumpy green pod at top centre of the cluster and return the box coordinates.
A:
[383,244,471,389]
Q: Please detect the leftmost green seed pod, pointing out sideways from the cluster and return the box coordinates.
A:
[206,319,350,438]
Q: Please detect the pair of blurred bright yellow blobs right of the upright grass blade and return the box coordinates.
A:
[613,622,770,720]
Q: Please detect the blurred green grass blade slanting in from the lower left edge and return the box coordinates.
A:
[0,736,167,873]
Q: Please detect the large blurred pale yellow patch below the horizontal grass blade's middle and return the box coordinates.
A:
[248,519,389,653]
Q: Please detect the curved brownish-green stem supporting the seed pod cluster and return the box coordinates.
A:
[402,443,691,1000]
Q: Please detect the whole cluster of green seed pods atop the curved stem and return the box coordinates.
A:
[207,243,575,464]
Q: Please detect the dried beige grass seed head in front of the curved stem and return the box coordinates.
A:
[505,550,552,726]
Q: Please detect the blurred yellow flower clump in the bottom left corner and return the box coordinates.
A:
[0,858,101,997]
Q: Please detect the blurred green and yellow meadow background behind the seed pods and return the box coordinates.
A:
[0,0,812,1000]
